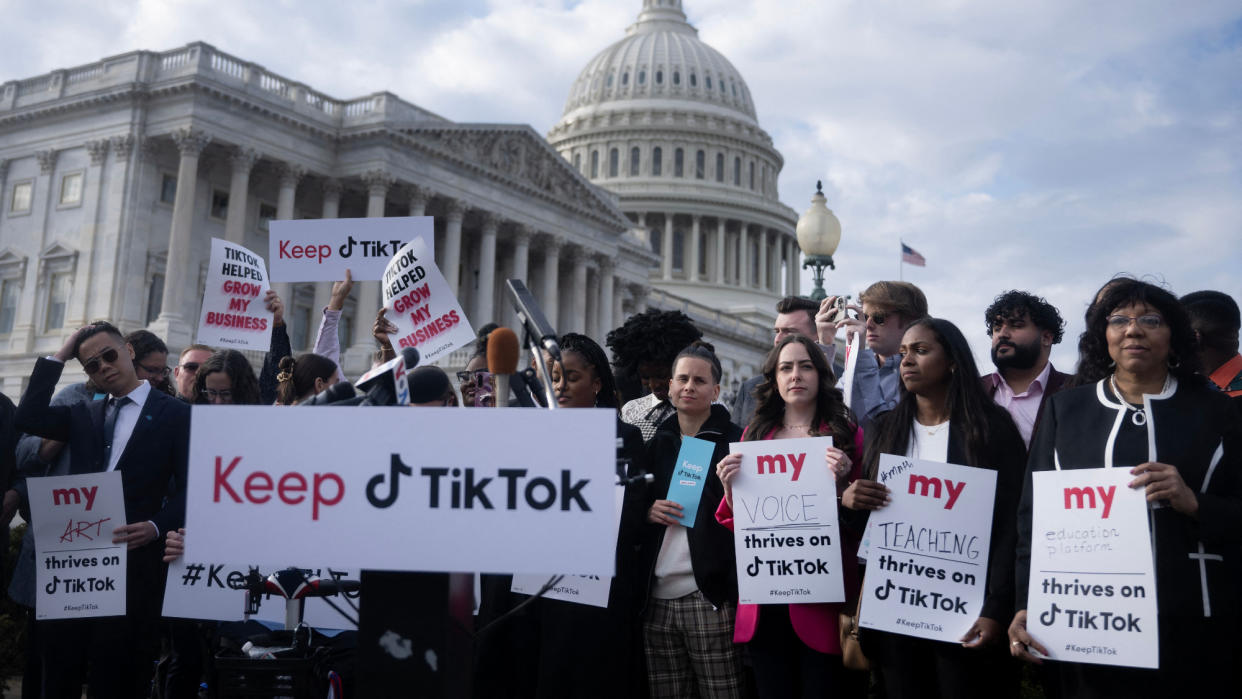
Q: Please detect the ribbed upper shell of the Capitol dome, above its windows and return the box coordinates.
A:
[565,1,758,125]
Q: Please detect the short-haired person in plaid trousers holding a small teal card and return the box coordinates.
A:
[642,340,744,699]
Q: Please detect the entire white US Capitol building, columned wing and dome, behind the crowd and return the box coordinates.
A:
[0,0,799,397]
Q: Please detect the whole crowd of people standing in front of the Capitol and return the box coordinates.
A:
[0,277,1242,699]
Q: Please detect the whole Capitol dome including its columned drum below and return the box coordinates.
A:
[548,0,800,379]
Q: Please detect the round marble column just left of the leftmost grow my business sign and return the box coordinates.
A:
[152,127,211,348]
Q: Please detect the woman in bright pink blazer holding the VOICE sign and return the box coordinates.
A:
[715,335,862,699]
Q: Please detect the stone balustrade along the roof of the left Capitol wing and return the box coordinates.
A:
[0,42,445,127]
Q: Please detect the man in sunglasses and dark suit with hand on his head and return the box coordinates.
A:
[16,322,190,698]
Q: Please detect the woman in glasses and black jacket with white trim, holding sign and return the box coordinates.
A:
[1009,279,1242,697]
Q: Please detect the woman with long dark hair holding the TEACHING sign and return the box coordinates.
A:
[841,318,1026,699]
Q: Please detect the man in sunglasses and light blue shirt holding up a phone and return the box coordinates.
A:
[815,282,928,431]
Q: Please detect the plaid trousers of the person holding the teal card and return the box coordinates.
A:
[642,590,745,699]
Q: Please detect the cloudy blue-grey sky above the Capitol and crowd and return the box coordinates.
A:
[0,0,1242,370]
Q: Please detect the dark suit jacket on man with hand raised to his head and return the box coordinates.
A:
[16,358,190,533]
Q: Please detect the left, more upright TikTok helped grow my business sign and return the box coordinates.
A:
[196,238,272,351]
